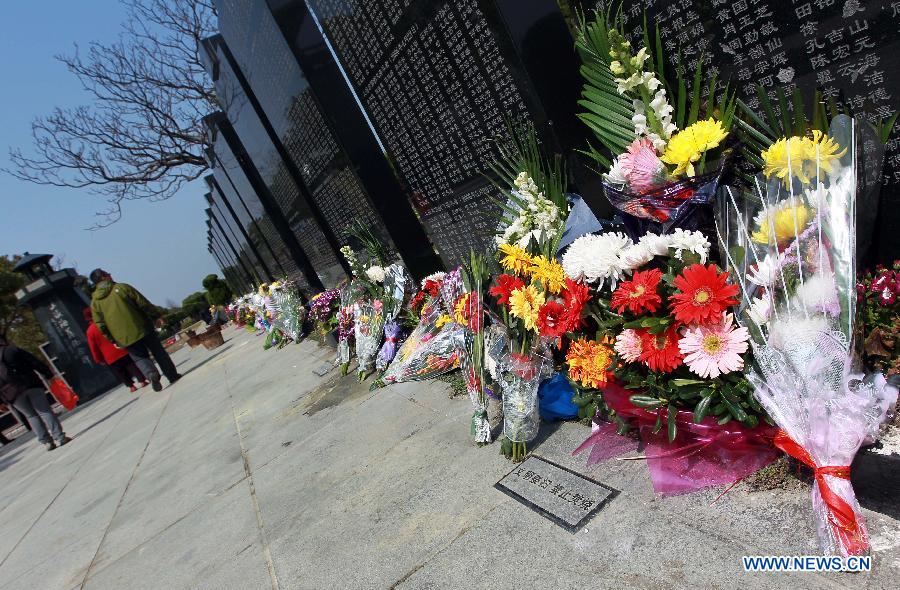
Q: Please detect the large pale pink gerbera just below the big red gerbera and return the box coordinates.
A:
[678,313,750,379]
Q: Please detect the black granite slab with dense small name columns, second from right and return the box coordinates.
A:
[294,0,581,264]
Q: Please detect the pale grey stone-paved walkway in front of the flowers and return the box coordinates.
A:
[0,329,900,590]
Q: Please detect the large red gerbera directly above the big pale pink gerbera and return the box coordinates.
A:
[671,264,738,324]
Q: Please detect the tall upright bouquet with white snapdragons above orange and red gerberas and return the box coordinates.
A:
[489,129,583,461]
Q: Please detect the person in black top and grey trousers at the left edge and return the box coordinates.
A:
[0,338,72,451]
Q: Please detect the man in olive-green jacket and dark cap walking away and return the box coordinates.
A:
[90,268,181,391]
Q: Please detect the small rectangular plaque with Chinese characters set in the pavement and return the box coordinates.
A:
[494,455,618,533]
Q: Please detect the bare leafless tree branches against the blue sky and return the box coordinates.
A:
[7,0,218,227]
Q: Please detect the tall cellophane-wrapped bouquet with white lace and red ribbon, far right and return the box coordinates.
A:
[717,115,897,556]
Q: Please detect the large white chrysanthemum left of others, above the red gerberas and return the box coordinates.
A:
[562,232,632,288]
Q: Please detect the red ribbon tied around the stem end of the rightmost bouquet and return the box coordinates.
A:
[773,430,869,555]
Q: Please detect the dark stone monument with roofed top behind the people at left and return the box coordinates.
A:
[13,252,118,400]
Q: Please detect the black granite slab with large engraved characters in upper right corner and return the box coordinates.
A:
[567,0,900,262]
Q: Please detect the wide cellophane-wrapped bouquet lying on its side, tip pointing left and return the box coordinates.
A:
[381,301,464,384]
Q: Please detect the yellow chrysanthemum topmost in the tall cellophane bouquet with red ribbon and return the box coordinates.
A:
[761,131,847,186]
